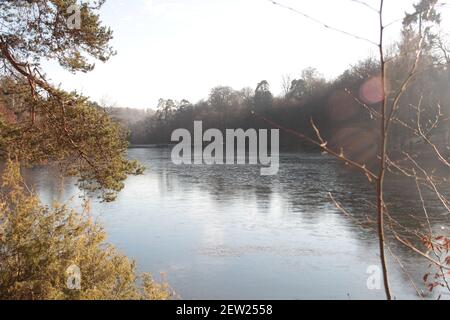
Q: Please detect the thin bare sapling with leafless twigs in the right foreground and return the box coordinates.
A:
[268,0,450,299]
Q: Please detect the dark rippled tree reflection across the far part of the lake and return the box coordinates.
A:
[23,148,448,298]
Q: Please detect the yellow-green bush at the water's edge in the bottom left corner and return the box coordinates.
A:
[0,161,174,300]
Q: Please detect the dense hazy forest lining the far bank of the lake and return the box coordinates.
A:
[129,4,450,168]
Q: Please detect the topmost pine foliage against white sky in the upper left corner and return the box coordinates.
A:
[0,0,114,72]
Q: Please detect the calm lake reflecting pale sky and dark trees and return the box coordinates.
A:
[26,147,449,299]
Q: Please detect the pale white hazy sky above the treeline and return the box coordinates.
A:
[47,0,450,108]
